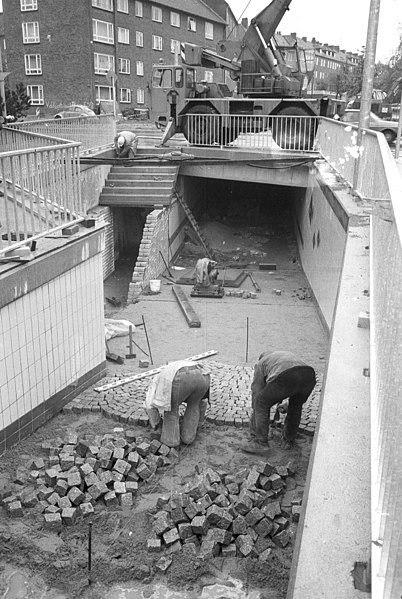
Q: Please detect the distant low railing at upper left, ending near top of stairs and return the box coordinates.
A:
[9,114,116,153]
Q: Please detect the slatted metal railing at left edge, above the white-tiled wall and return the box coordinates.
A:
[0,127,85,254]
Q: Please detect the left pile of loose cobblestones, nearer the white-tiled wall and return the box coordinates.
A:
[0,430,178,531]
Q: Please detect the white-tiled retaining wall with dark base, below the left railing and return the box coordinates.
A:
[0,229,105,454]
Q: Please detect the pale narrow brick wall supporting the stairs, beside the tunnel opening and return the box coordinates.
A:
[127,209,168,303]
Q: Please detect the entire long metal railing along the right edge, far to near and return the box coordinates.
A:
[316,119,402,599]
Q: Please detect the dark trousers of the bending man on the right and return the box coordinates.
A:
[250,366,315,443]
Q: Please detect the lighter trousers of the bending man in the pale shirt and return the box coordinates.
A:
[160,366,209,447]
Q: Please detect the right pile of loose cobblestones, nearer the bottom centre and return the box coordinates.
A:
[147,462,301,562]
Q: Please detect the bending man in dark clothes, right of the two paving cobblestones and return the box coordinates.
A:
[242,351,316,453]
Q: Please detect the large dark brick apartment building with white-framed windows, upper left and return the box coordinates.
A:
[3,0,226,116]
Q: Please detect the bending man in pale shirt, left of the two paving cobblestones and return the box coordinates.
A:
[145,360,210,447]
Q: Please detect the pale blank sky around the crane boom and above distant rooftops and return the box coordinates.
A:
[227,0,402,62]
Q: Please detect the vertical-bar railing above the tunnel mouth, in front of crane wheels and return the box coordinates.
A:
[181,114,319,152]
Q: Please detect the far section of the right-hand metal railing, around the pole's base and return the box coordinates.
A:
[316,118,391,199]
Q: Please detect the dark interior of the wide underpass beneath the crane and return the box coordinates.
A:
[186,178,298,268]
